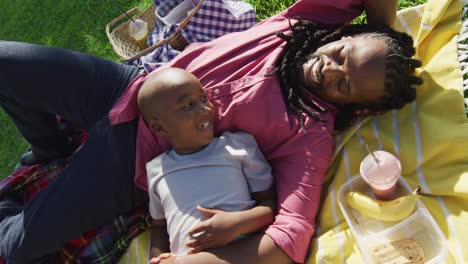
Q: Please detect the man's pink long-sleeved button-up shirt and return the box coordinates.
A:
[110,0,362,262]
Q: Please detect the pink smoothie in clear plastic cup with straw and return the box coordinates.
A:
[360,150,401,200]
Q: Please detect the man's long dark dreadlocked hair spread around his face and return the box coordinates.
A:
[274,20,422,130]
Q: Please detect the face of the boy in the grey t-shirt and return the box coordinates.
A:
[152,81,215,154]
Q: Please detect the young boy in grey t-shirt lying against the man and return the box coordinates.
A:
[138,68,275,263]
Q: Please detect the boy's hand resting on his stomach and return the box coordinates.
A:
[186,206,240,254]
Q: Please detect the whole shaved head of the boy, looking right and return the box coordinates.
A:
[138,68,215,154]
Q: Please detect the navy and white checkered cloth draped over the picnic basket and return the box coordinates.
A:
[132,0,257,72]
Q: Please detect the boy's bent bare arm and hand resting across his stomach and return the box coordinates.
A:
[187,188,276,253]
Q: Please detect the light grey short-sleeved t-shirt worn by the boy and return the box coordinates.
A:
[146,132,273,255]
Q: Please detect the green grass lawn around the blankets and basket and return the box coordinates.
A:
[0,0,426,179]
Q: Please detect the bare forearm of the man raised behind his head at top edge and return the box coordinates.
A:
[364,0,398,27]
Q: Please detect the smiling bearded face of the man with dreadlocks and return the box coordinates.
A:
[300,35,387,106]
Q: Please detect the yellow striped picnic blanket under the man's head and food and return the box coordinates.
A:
[120,0,468,264]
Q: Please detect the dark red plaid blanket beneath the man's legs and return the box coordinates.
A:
[0,159,150,264]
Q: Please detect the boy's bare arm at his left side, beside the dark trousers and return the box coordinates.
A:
[150,219,170,259]
